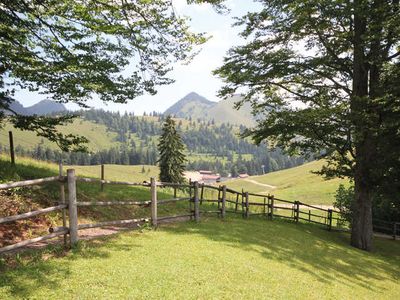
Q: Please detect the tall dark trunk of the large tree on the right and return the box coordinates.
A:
[350,0,374,251]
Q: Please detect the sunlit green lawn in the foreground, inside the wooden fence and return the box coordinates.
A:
[0,217,400,299]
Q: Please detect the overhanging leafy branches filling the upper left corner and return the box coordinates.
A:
[0,0,223,150]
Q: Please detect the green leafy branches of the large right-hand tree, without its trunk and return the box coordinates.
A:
[216,0,400,177]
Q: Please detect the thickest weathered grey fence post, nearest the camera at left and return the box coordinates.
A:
[67,169,78,246]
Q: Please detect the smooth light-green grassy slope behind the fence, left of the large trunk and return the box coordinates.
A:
[226,161,348,204]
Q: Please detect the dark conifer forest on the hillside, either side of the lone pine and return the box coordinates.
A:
[81,110,305,176]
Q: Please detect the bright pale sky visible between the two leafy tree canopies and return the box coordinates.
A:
[15,0,258,114]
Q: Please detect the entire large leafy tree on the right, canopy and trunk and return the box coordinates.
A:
[216,0,400,250]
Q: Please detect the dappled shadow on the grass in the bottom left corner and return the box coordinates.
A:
[0,230,147,299]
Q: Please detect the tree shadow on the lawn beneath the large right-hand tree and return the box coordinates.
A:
[164,217,400,291]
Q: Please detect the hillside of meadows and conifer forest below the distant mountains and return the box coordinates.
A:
[0,110,310,176]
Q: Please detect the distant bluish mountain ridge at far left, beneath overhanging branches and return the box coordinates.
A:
[2,99,67,116]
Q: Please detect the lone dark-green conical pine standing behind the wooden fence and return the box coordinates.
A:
[158,116,186,183]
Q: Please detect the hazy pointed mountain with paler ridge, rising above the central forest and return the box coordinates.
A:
[164,92,255,127]
